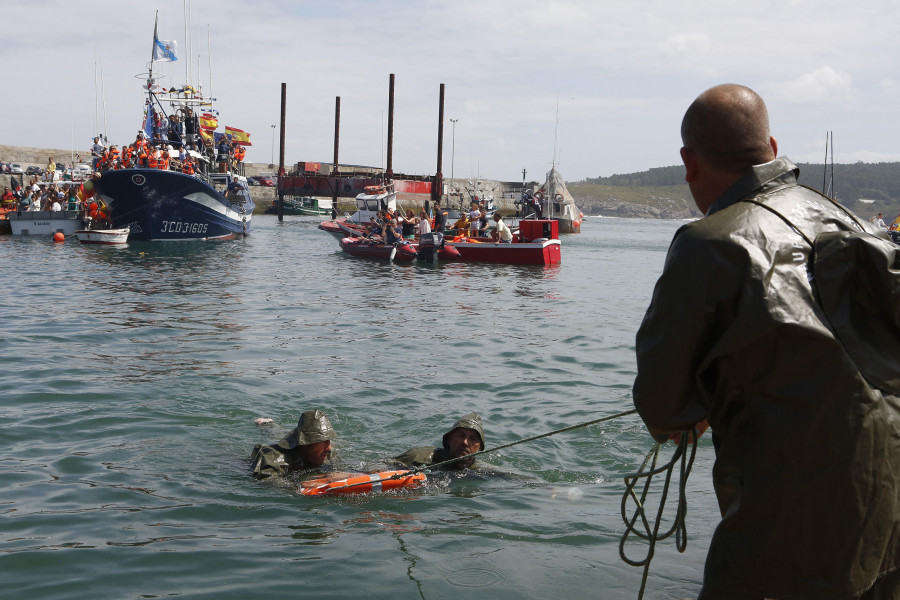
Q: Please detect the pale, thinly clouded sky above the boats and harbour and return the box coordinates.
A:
[0,0,900,181]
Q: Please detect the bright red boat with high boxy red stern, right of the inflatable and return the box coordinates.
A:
[445,219,562,265]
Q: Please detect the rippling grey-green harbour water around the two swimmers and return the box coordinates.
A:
[0,216,718,600]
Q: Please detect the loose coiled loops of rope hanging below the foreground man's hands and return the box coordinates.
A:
[619,429,700,600]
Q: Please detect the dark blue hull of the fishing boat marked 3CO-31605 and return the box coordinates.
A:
[94,169,254,241]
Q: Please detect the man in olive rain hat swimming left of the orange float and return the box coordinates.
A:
[250,410,337,479]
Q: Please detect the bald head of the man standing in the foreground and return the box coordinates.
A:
[681,83,775,173]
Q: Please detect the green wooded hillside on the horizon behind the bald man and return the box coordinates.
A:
[566,162,900,220]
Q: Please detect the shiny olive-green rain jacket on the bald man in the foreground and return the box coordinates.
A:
[634,158,900,600]
